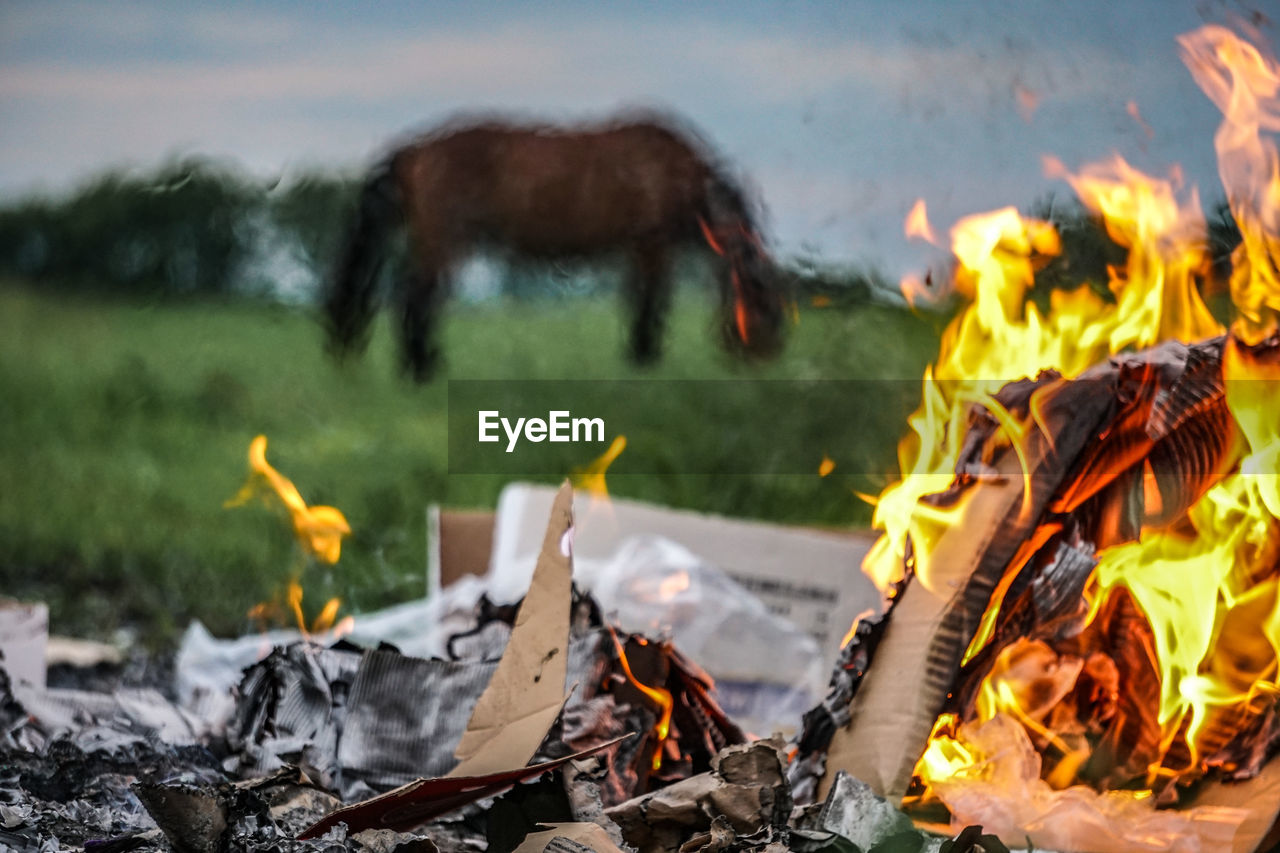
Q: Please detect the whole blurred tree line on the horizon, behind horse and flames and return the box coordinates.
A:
[0,156,1240,305]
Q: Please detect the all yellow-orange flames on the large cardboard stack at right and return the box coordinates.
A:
[863,16,1280,804]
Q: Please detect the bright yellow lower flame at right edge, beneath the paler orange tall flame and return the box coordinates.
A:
[1097,338,1280,761]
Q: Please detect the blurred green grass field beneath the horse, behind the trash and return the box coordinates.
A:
[0,283,937,644]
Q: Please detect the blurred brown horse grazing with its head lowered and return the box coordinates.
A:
[325,115,785,380]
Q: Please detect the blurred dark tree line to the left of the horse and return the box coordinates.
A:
[0,158,358,296]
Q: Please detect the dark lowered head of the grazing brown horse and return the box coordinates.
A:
[703,216,787,359]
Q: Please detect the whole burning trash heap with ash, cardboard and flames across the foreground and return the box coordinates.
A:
[0,14,1280,853]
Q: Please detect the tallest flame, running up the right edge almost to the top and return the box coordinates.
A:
[1059,19,1280,779]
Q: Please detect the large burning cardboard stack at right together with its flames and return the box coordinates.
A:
[799,19,1280,849]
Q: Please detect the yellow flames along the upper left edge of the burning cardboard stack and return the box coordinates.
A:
[863,151,1221,589]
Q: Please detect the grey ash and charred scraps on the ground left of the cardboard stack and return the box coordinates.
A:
[0,589,996,853]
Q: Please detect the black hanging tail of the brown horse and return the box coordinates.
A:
[324,156,402,355]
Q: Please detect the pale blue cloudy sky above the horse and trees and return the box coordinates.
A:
[0,0,1276,278]
